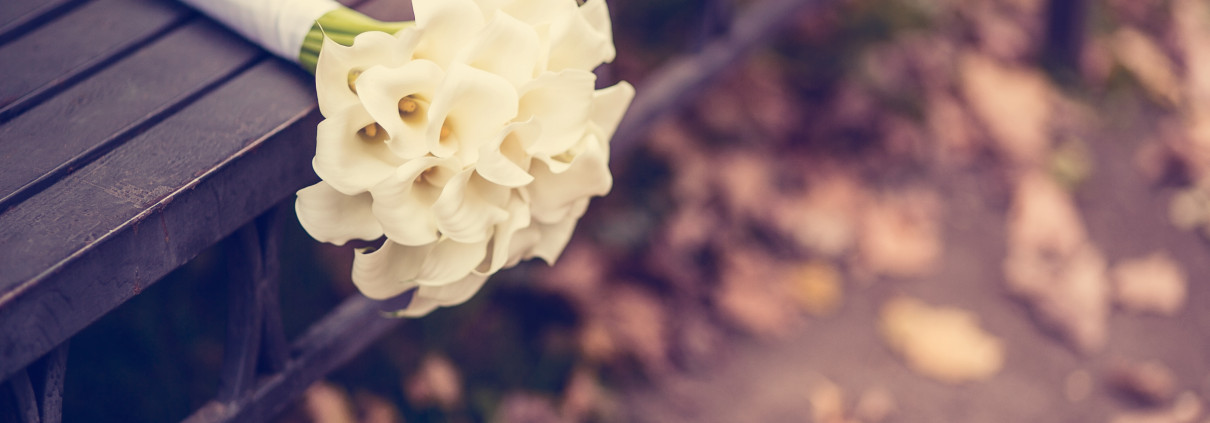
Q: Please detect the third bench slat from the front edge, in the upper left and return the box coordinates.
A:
[0,0,192,122]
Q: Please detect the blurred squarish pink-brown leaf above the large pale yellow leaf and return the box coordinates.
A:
[858,190,941,277]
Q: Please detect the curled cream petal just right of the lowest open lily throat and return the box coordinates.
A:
[433,169,508,243]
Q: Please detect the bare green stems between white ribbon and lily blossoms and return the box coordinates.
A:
[299,7,416,74]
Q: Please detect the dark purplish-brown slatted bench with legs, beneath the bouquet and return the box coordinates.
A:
[0,0,837,422]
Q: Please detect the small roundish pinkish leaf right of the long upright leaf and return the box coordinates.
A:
[1112,251,1186,315]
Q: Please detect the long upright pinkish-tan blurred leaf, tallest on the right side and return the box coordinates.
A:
[1004,173,1110,353]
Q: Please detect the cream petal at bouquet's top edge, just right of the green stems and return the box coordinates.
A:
[411,0,485,69]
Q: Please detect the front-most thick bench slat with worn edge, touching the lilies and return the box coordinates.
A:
[0,58,319,379]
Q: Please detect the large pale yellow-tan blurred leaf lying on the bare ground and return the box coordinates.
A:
[878,297,1004,383]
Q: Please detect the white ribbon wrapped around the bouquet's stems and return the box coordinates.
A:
[183,0,341,62]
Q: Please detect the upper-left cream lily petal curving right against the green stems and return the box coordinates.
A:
[315,28,419,117]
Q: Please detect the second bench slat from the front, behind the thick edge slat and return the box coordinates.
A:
[0,21,264,210]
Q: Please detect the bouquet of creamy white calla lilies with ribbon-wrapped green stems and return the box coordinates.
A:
[185,0,634,317]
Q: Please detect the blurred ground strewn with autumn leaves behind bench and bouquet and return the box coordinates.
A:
[64,0,1210,423]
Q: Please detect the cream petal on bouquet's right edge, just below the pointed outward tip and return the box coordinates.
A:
[526,134,613,224]
